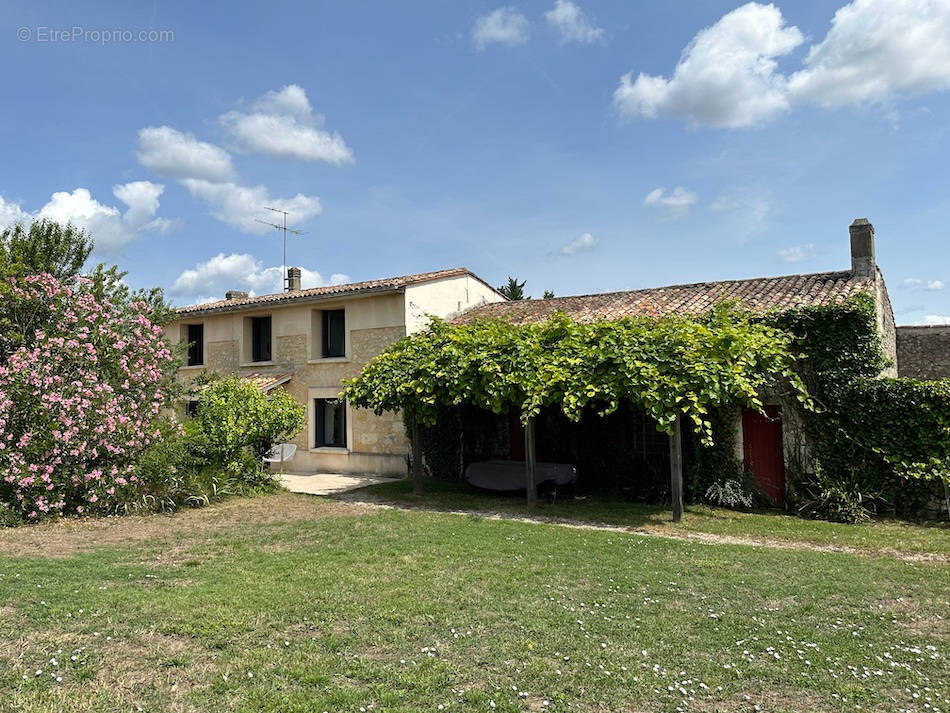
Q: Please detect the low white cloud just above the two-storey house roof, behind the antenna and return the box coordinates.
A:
[169,253,350,304]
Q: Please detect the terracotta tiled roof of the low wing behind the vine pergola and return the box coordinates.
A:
[455,271,873,324]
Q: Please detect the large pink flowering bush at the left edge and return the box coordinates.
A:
[0,274,175,521]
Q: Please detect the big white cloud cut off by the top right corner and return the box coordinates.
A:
[788,0,950,107]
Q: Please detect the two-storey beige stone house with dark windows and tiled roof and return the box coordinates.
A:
[166,267,504,474]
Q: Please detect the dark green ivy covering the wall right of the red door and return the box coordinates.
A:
[766,294,950,514]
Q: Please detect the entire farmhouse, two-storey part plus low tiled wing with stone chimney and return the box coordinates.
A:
[168,218,950,503]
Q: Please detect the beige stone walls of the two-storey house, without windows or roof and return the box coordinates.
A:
[166,274,502,474]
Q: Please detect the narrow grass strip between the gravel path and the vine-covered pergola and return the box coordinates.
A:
[357,480,950,559]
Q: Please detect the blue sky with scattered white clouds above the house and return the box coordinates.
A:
[0,0,950,323]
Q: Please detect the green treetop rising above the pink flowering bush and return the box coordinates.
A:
[0,220,93,280]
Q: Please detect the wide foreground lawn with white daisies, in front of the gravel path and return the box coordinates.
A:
[0,494,950,713]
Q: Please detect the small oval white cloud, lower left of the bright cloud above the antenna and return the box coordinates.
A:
[136,126,235,182]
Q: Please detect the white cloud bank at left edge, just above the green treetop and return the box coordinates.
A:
[0,181,175,254]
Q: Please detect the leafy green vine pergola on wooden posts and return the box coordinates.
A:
[342,304,809,520]
